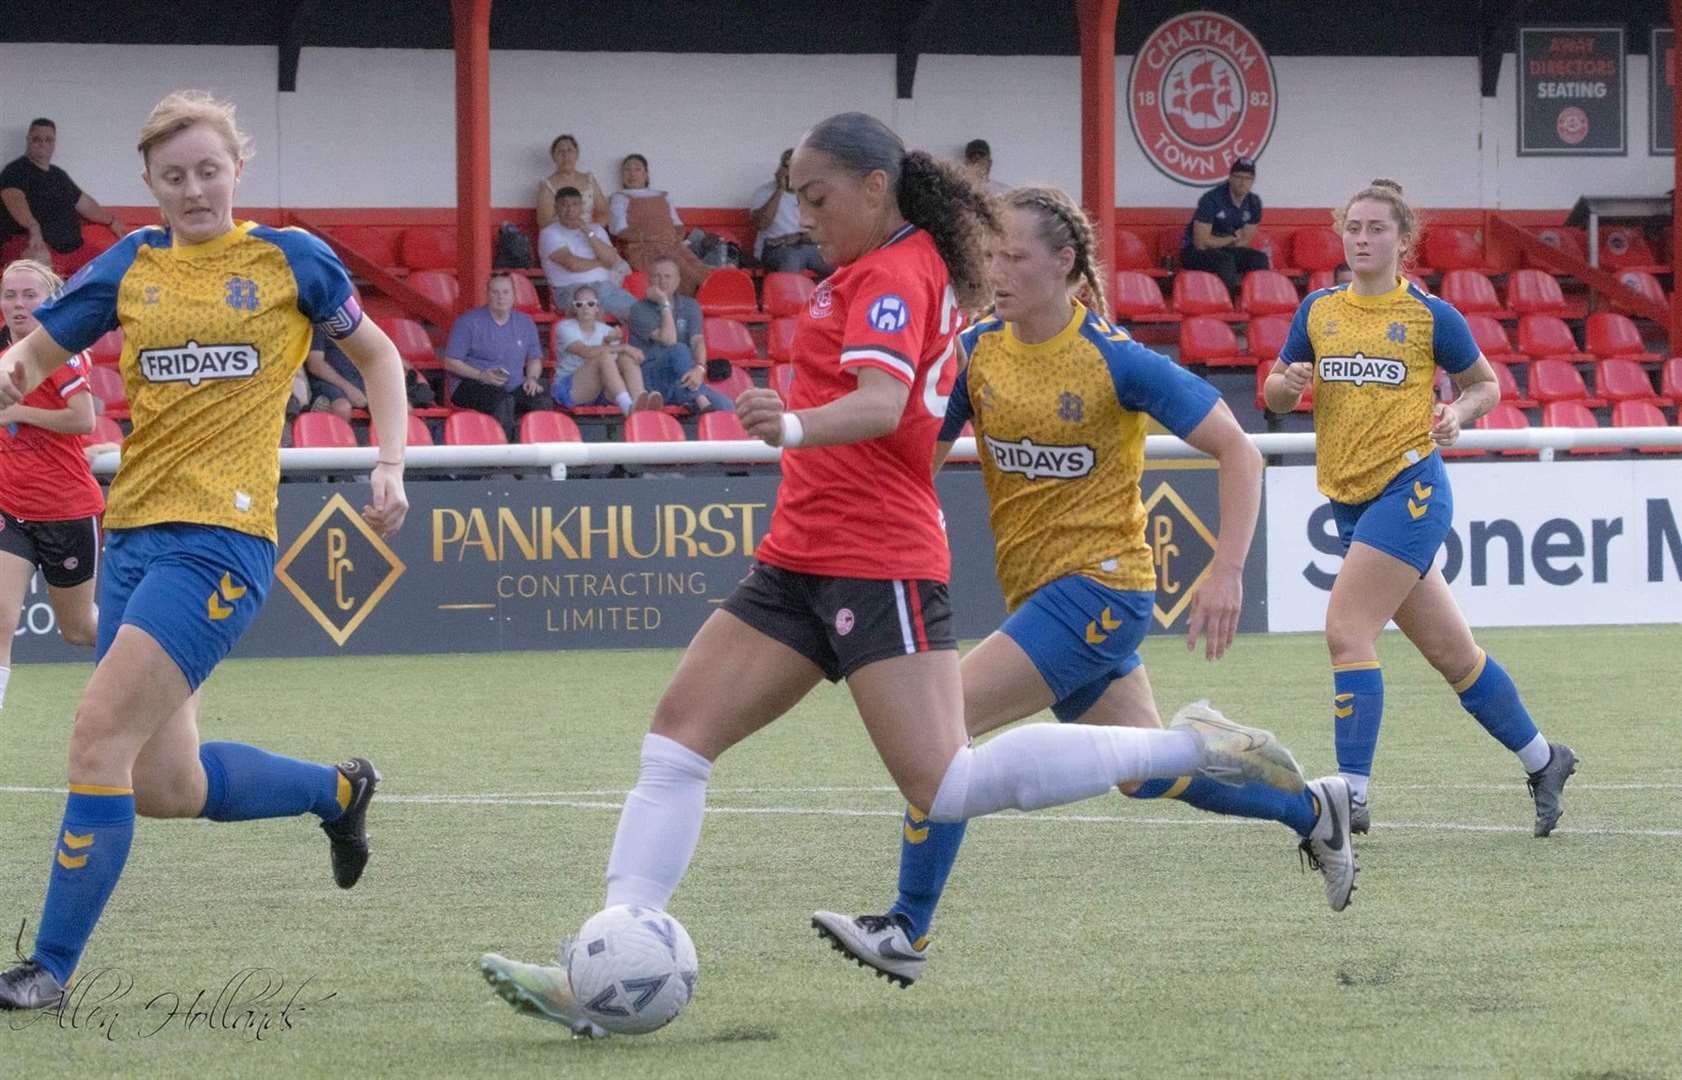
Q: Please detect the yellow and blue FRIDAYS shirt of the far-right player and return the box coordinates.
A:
[1278,279,1480,505]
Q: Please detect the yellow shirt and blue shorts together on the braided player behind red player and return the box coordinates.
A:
[940,303,1219,720]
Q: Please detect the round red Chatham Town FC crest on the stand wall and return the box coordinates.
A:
[1127,12,1278,187]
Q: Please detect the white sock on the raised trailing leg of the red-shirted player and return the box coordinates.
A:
[928,723,1198,821]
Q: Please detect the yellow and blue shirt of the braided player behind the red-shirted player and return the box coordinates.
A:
[940,303,1219,611]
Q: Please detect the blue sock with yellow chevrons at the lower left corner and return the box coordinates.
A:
[34,784,135,984]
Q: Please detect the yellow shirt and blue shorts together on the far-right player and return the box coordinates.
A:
[1278,279,1482,577]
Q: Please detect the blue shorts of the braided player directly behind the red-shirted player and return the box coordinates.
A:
[999,574,1156,723]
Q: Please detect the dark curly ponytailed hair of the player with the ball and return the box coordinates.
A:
[801,113,999,310]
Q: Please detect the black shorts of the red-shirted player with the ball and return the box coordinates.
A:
[723,562,957,683]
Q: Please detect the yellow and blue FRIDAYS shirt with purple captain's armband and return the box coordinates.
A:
[35,222,362,542]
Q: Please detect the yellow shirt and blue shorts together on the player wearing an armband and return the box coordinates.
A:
[35,222,362,690]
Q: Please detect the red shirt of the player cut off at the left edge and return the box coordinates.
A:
[0,353,104,521]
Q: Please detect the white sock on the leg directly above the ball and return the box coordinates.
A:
[606,732,713,910]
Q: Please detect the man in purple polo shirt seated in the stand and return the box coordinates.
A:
[444,273,548,437]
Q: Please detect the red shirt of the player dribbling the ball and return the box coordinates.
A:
[755,225,962,582]
